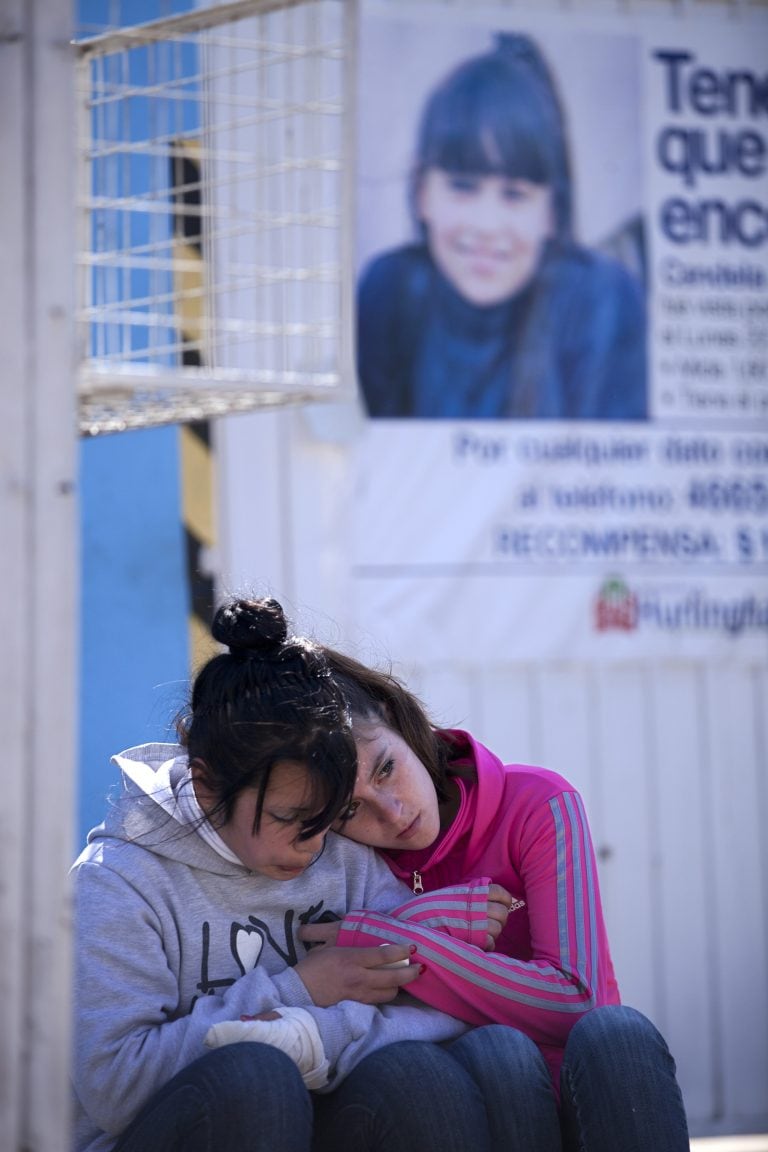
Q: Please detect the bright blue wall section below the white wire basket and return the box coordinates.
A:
[78,427,189,841]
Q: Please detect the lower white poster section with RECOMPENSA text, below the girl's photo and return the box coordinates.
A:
[353,422,768,660]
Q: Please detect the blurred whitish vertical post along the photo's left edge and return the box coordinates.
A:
[0,0,78,1152]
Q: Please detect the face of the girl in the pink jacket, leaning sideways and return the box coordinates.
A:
[337,722,440,851]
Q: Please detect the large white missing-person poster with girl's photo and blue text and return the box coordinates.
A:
[353,2,768,660]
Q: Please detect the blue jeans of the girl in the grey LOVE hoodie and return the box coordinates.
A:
[108,1033,502,1152]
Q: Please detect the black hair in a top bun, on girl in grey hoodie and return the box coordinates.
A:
[177,598,357,840]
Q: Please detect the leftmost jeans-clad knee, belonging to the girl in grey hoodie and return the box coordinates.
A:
[114,1044,312,1152]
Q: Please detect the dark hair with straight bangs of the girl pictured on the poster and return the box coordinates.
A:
[410,32,572,242]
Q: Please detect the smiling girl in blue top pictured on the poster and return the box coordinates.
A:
[358,33,647,420]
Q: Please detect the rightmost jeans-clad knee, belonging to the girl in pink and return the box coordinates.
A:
[560,1005,690,1152]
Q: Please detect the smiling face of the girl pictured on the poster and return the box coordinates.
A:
[418,168,554,308]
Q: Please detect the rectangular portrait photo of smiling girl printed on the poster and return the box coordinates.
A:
[356,13,648,420]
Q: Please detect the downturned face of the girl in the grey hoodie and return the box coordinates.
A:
[203,760,327,880]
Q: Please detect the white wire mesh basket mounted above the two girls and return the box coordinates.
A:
[78,0,349,435]
